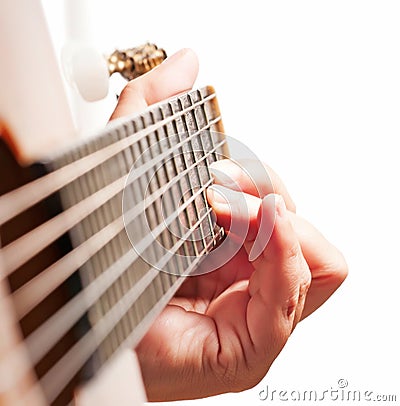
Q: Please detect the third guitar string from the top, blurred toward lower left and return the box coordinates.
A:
[13,141,225,318]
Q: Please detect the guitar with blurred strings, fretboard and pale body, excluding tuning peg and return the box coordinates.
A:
[0,1,228,405]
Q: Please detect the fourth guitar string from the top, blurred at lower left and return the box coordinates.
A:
[21,180,211,368]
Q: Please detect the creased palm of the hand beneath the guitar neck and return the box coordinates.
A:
[138,248,266,398]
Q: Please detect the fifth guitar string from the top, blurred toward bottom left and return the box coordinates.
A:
[36,209,216,402]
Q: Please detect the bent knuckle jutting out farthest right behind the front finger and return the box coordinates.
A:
[289,213,348,319]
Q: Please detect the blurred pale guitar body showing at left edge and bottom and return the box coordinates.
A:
[0,0,145,406]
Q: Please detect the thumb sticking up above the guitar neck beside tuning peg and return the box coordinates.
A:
[110,49,199,120]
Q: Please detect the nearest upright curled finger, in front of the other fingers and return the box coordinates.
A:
[247,195,311,357]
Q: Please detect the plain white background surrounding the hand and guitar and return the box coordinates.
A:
[44,0,400,405]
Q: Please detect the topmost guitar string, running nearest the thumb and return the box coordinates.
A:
[0,93,215,225]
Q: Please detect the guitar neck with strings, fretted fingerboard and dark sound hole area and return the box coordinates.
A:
[0,87,228,404]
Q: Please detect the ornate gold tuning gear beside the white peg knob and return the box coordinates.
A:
[107,43,167,80]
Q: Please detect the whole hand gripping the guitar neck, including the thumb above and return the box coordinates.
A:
[111,49,347,401]
